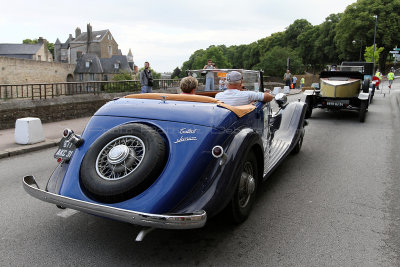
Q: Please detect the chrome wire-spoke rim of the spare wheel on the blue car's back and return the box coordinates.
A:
[96,135,146,180]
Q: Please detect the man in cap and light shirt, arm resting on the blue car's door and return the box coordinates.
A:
[215,71,274,106]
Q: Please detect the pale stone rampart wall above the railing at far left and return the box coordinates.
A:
[0,57,75,84]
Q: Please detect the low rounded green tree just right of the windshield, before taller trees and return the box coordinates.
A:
[257,46,304,77]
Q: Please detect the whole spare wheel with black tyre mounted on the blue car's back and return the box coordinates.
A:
[80,123,167,203]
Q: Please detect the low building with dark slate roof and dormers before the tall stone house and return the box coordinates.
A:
[74,54,132,82]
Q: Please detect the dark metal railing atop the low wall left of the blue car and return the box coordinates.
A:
[0,79,179,100]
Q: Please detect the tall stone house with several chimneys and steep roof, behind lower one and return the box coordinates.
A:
[54,24,118,64]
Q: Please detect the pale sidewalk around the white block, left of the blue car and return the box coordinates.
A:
[0,89,301,159]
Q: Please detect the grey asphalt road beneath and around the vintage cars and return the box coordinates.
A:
[0,90,400,266]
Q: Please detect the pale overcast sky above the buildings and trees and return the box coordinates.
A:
[0,0,356,72]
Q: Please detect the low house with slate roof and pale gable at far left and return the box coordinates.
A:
[0,37,53,62]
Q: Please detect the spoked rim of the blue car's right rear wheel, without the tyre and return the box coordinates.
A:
[239,161,255,208]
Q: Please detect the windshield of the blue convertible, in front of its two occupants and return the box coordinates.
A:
[186,69,263,92]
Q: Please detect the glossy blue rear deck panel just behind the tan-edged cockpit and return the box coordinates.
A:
[95,98,238,128]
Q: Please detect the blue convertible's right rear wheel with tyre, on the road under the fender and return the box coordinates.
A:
[230,151,258,223]
